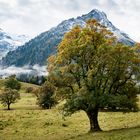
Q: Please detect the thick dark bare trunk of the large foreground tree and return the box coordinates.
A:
[86,109,101,132]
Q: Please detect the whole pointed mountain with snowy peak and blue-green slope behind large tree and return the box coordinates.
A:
[2,9,135,67]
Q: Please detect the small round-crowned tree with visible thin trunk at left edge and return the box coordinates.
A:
[0,88,20,110]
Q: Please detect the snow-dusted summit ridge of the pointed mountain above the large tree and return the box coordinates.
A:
[50,9,135,46]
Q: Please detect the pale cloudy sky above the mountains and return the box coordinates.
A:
[0,0,140,42]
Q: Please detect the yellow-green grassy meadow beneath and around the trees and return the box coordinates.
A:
[0,83,140,140]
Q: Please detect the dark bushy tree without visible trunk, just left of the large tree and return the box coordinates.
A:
[37,82,56,109]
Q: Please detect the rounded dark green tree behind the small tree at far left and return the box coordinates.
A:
[4,76,21,90]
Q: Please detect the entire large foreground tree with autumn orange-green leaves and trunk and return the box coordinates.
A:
[48,20,140,132]
